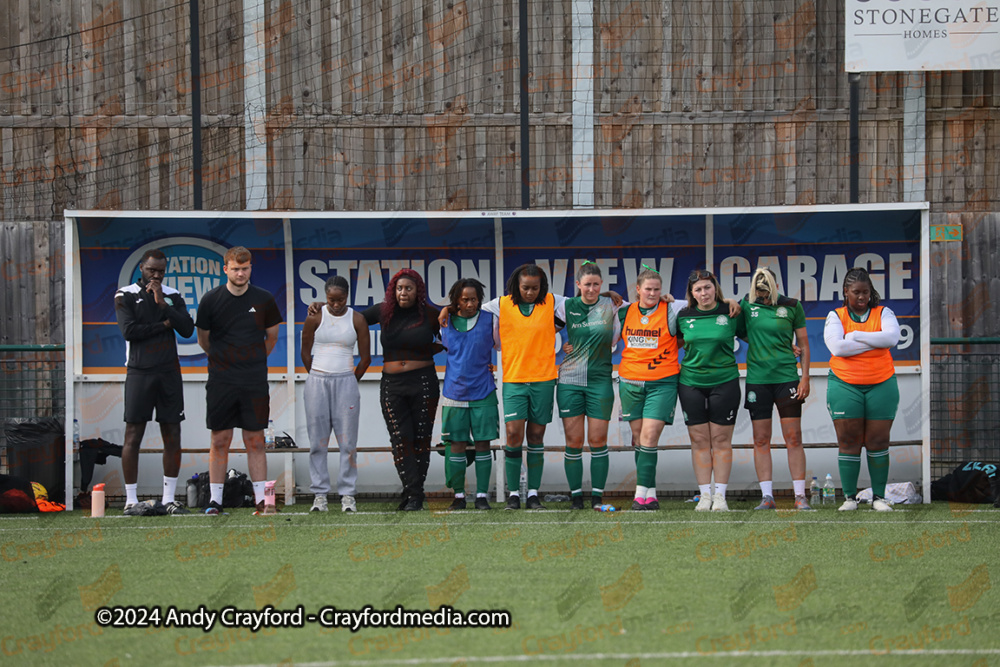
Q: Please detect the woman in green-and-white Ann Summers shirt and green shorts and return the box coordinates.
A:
[556,261,621,510]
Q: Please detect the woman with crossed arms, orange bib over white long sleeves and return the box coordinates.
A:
[823,268,899,512]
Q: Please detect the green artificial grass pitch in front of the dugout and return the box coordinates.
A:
[0,501,1000,667]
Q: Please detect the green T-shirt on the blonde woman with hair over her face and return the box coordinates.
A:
[740,294,806,384]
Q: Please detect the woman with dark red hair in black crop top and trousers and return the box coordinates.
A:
[363,269,443,512]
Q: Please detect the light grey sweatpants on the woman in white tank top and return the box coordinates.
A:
[305,373,361,496]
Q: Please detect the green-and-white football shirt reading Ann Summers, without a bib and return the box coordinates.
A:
[559,296,617,387]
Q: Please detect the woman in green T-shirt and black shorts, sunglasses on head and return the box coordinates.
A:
[677,270,746,512]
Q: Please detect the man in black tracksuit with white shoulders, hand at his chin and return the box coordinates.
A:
[115,250,194,514]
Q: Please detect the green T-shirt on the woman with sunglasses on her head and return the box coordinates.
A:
[677,303,746,387]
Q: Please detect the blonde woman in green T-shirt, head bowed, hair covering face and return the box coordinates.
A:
[740,268,812,510]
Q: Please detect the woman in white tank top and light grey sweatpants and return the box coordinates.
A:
[302,276,371,512]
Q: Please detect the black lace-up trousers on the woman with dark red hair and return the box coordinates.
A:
[379,366,441,502]
